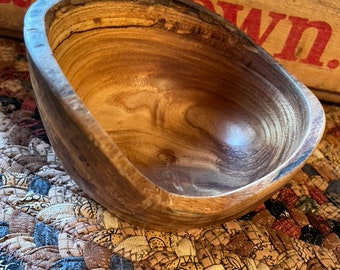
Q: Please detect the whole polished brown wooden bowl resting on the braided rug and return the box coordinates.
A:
[24,0,325,229]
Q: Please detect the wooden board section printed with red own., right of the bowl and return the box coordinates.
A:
[194,0,340,102]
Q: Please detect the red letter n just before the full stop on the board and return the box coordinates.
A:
[273,17,332,66]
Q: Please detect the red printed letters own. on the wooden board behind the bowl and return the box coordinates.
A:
[194,0,339,69]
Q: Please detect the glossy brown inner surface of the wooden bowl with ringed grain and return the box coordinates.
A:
[47,1,308,196]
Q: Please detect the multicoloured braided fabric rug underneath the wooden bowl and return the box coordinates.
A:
[0,37,340,270]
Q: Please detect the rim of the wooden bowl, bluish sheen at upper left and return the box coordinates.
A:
[24,0,325,226]
